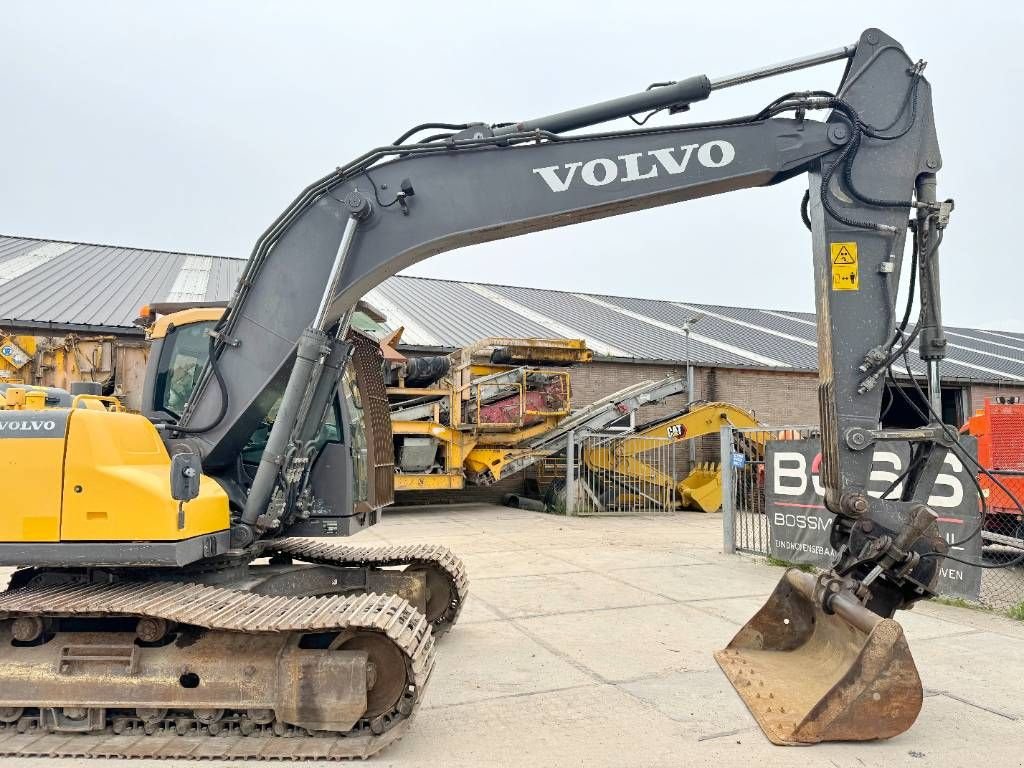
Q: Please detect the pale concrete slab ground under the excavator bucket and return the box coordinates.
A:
[8,505,1024,768]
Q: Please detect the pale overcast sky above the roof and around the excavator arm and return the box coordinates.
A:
[0,0,1024,331]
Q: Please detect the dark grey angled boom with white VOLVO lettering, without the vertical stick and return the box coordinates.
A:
[178,112,837,544]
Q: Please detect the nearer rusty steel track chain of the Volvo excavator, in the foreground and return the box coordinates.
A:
[0,582,434,760]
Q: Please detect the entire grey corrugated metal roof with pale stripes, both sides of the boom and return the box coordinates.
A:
[0,230,1024,385]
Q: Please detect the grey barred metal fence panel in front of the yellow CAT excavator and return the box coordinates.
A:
[536,434,687,517]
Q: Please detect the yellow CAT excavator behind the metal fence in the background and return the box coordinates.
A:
[583,402,764,512]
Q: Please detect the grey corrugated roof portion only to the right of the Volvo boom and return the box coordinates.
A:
[367,275,1024,386]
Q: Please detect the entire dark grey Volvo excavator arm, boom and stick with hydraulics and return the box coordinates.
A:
[169,29,951,741]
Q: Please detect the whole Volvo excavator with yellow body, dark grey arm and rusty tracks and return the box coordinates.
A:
[0,29,957,759]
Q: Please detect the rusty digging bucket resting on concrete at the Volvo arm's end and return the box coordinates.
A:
[715,568,924,744]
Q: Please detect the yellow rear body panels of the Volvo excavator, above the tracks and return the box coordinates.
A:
[0,405,229,544]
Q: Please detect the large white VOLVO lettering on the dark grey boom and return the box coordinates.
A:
[532,139,736,191]
